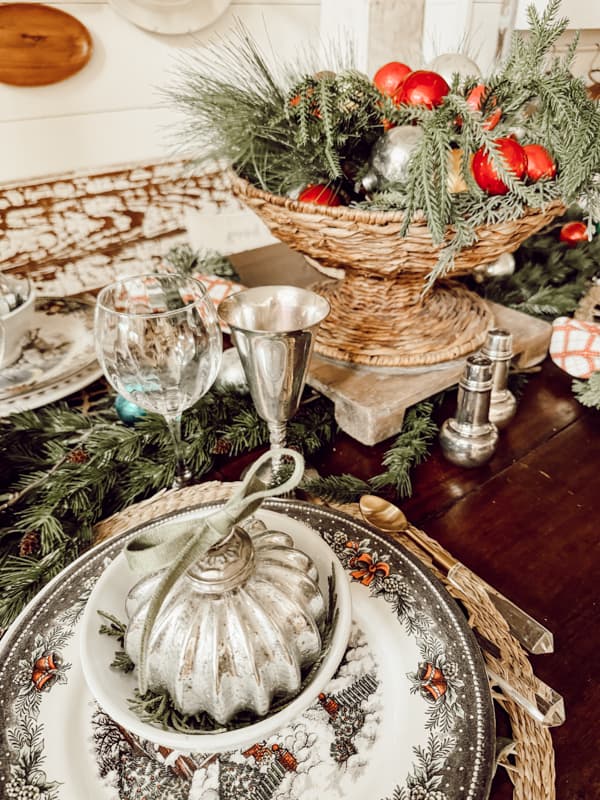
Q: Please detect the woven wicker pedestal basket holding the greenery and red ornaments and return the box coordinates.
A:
[231,174,565,367]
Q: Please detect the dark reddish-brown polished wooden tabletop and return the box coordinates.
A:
[211,361,600,800]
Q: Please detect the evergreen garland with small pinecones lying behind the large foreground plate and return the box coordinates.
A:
[0,390,335,628]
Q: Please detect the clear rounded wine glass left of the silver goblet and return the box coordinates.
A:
[95,274,222,488]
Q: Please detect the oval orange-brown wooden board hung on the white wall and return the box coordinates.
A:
[0,3,92,86]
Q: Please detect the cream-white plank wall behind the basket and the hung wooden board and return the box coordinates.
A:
[0,0,600,183]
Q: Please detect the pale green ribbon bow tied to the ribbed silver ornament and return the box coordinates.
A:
[125,448,304,695]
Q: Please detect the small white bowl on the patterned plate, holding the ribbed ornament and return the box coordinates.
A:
[81,509,352,753]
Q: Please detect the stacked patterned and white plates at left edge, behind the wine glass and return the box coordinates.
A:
[0,298,102,416]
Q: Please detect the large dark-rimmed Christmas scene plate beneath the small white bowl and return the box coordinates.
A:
[0,500,494,800]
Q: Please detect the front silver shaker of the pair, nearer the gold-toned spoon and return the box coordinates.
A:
[440,355,498,467]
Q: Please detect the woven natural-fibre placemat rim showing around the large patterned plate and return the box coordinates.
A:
[94,481,556,800]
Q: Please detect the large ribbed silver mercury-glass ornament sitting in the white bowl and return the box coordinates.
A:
[125,520,326,724]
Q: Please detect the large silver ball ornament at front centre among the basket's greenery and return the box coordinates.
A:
[362,125,423,192]
